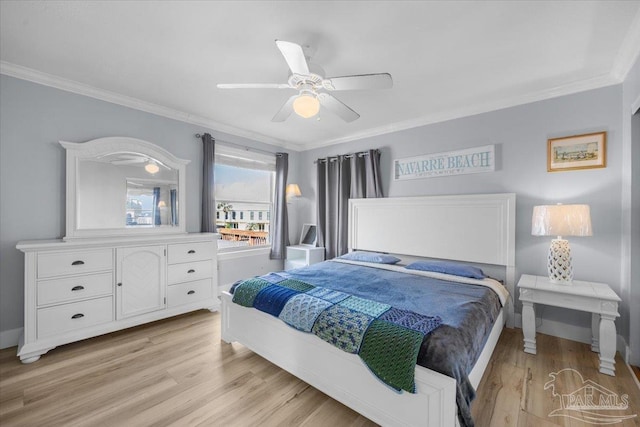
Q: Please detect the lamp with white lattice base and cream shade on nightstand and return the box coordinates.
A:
[531,204,593,285]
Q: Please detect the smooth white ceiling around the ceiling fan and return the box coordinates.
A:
[0,0,640,149]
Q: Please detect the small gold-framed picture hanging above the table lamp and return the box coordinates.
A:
[547,132,607,172]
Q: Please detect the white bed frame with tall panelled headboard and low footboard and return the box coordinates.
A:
[222,194,515,427]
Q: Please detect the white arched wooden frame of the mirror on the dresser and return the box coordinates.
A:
[59,137,190,240]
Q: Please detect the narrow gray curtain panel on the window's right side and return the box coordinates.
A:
[269,153,289,259]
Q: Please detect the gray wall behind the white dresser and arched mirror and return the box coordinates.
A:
[0,75,297,333]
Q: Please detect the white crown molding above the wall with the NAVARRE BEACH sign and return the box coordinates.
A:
[305,74,620,150]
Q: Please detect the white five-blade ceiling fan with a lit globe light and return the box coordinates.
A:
[217,40,393,122]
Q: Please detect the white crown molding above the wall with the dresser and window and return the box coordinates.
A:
[0,61,304,151]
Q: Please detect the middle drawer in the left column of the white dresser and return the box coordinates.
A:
[38,272,113,305]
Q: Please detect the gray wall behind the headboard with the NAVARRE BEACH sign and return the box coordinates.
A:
[299,85,629,354]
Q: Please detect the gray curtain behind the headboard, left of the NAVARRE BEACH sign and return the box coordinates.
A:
[317,150,383,259]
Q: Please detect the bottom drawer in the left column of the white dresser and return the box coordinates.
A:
[38,297,113,338]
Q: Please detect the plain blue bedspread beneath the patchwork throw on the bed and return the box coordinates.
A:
[232,261,500,426]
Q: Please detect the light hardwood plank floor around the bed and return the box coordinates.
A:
[0,311,640,427]
